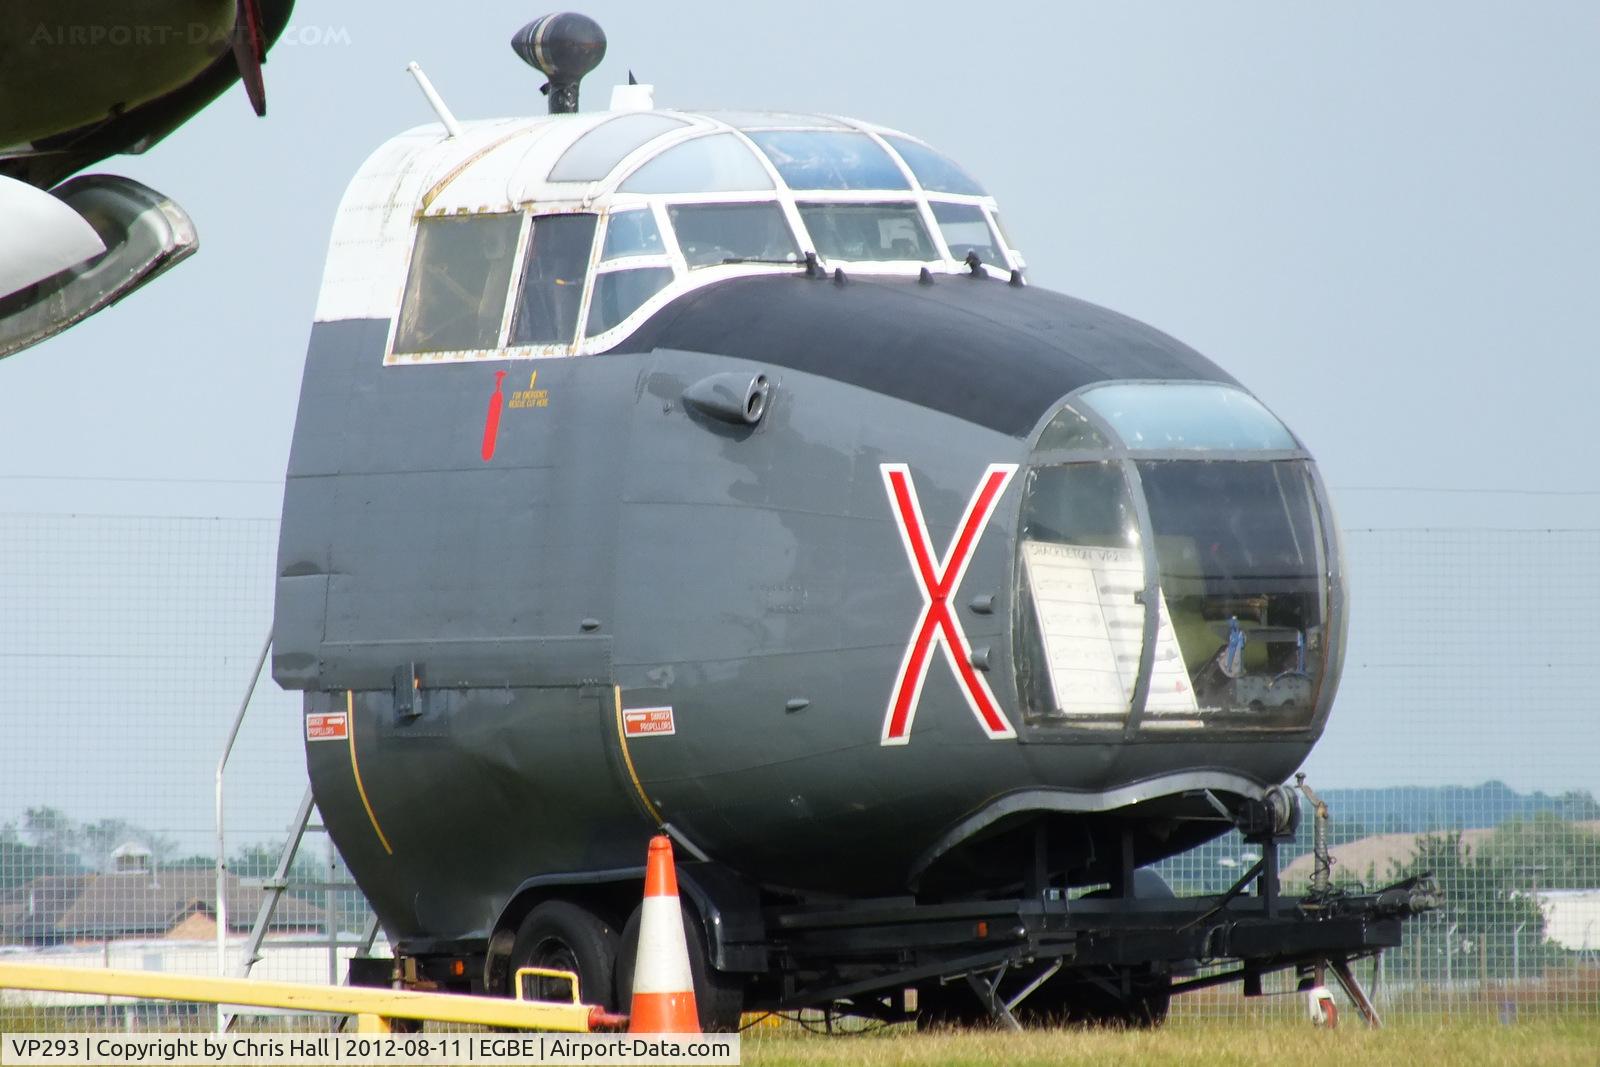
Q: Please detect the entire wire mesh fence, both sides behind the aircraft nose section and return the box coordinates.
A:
[0,515,1600,1024]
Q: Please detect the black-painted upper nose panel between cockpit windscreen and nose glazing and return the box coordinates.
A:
[614,275,1234,437]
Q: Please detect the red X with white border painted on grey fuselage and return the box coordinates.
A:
[878,464,1016,745]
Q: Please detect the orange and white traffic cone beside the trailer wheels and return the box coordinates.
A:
[627,833,701,1033]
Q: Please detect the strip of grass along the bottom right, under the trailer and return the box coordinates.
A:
[744,1017,1600,1067]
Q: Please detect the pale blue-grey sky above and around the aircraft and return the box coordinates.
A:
[0,0,1600,851]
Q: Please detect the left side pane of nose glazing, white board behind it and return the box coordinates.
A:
[1018,462,1144,726]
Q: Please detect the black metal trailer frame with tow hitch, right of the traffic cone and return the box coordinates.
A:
[742,781,1442,1027]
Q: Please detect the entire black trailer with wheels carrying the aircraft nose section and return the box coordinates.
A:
[360,781,1442,1029]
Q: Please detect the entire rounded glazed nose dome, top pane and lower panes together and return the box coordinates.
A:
[1013,382,1344,739]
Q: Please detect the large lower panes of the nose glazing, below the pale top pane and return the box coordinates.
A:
[1014,458,1333,731]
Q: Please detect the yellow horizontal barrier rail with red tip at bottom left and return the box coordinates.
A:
[0,963,627,1033]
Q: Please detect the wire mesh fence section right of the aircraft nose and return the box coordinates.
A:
[1163,530,1600,1017]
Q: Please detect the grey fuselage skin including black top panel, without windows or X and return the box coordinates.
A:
[272,277,1336,942]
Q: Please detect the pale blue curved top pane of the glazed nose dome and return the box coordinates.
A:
[1083,382,1299,451]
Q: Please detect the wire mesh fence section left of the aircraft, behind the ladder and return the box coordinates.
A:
[0,515,381,1029]
